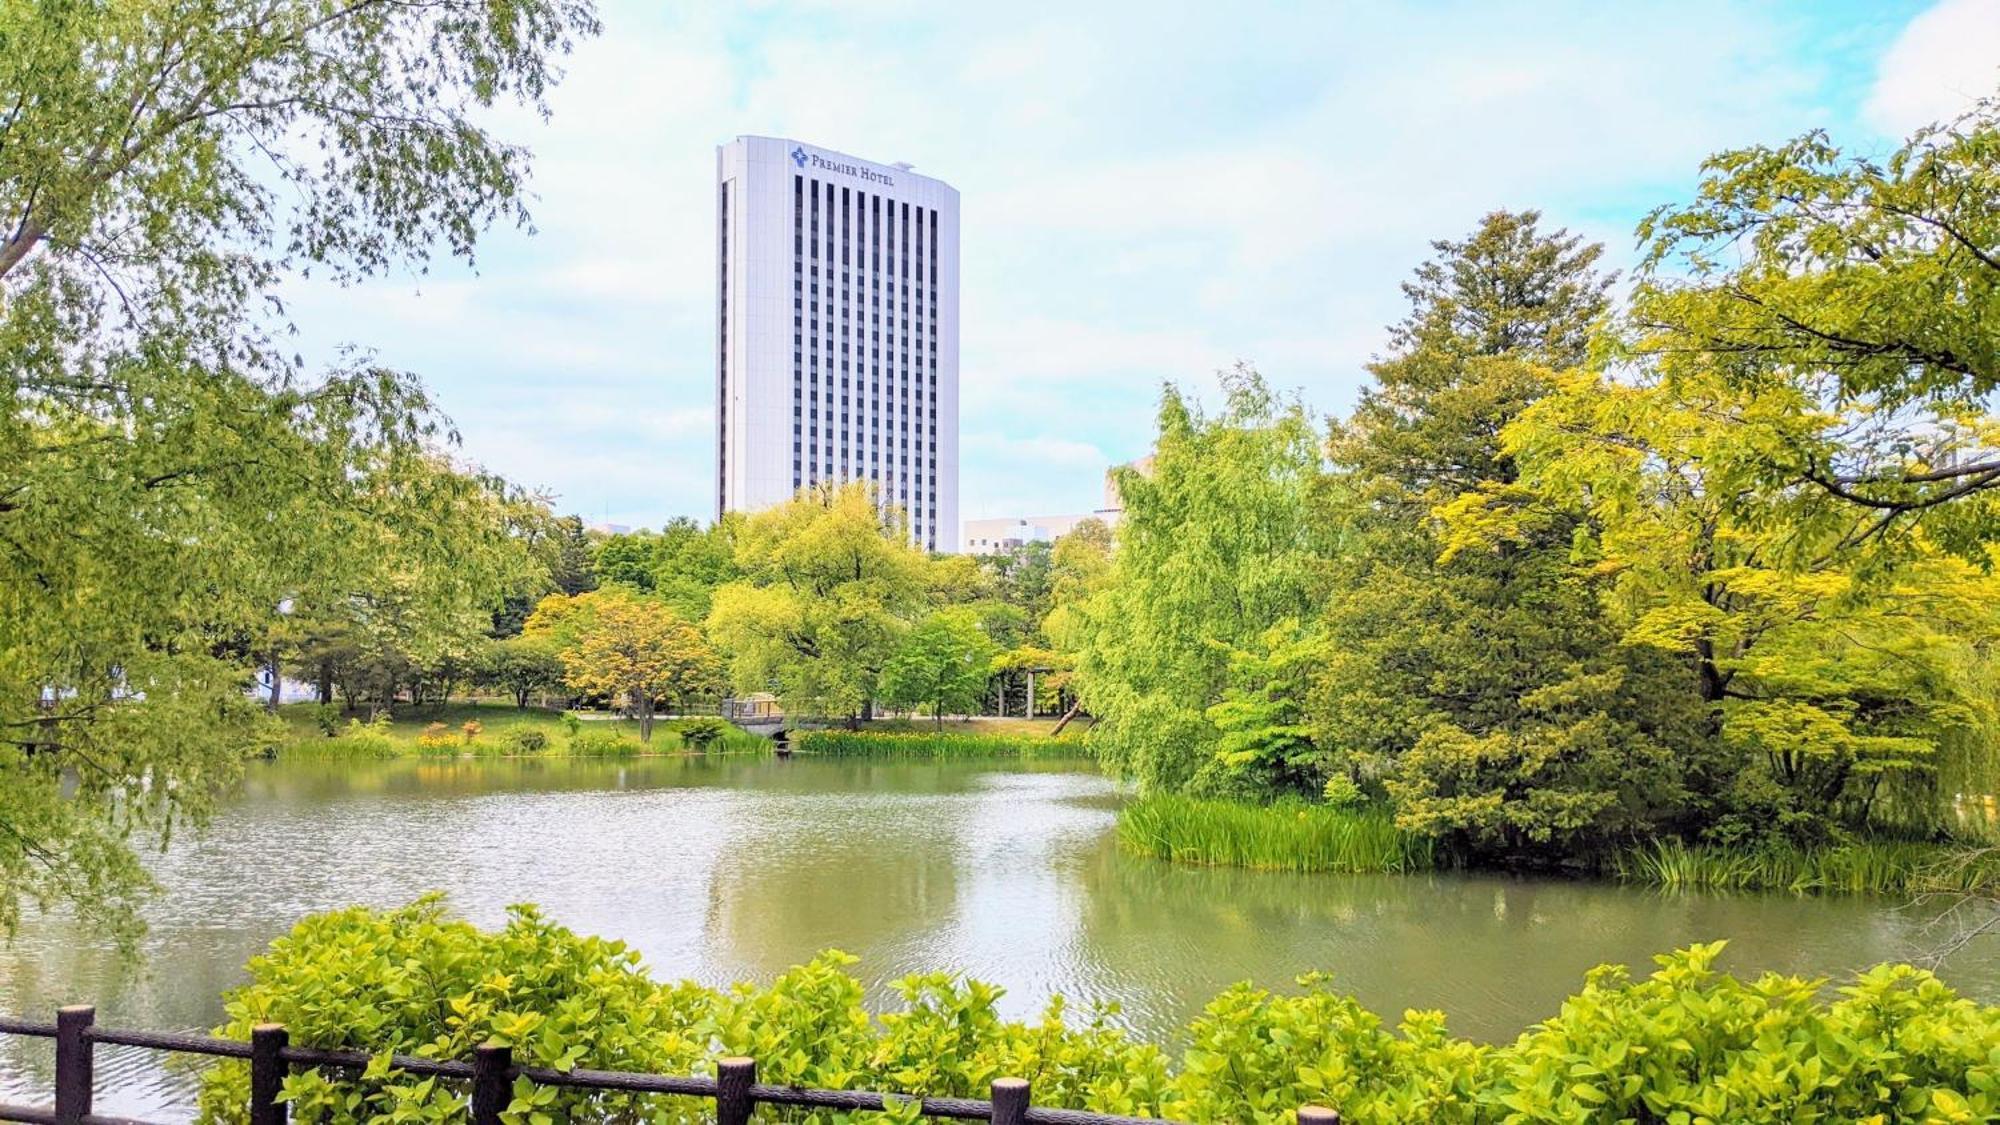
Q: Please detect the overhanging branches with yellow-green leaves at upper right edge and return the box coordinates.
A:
[1630,98,2000,552]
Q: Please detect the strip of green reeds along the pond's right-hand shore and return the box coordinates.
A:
[1612,841,2000,895]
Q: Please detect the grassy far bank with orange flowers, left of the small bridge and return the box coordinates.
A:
[278,701,770,759]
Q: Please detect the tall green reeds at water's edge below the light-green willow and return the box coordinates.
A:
[1118,795,1436,873]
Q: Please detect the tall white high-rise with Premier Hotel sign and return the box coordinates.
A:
[716,136,958,550]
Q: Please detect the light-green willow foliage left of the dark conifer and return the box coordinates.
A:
[1062,368,1328,789]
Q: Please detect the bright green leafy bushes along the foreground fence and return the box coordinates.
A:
[200,897,2000,1125]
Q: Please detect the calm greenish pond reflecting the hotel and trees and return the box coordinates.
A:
[0,755,2000,1119]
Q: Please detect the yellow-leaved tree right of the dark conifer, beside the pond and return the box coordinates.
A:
[1472,360,2000,839]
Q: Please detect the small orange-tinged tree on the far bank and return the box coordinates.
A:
[548,589,722,743]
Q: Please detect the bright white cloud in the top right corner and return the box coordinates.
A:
[1864,0,2000,136]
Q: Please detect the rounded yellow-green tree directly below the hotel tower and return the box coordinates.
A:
[708,484,932,719]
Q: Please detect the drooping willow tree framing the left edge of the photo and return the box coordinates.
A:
[0,0,596,935]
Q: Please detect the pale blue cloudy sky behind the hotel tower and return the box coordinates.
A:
[278,0,2000,526]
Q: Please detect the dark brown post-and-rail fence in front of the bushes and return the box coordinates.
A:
[0,1007,1340,1125]
